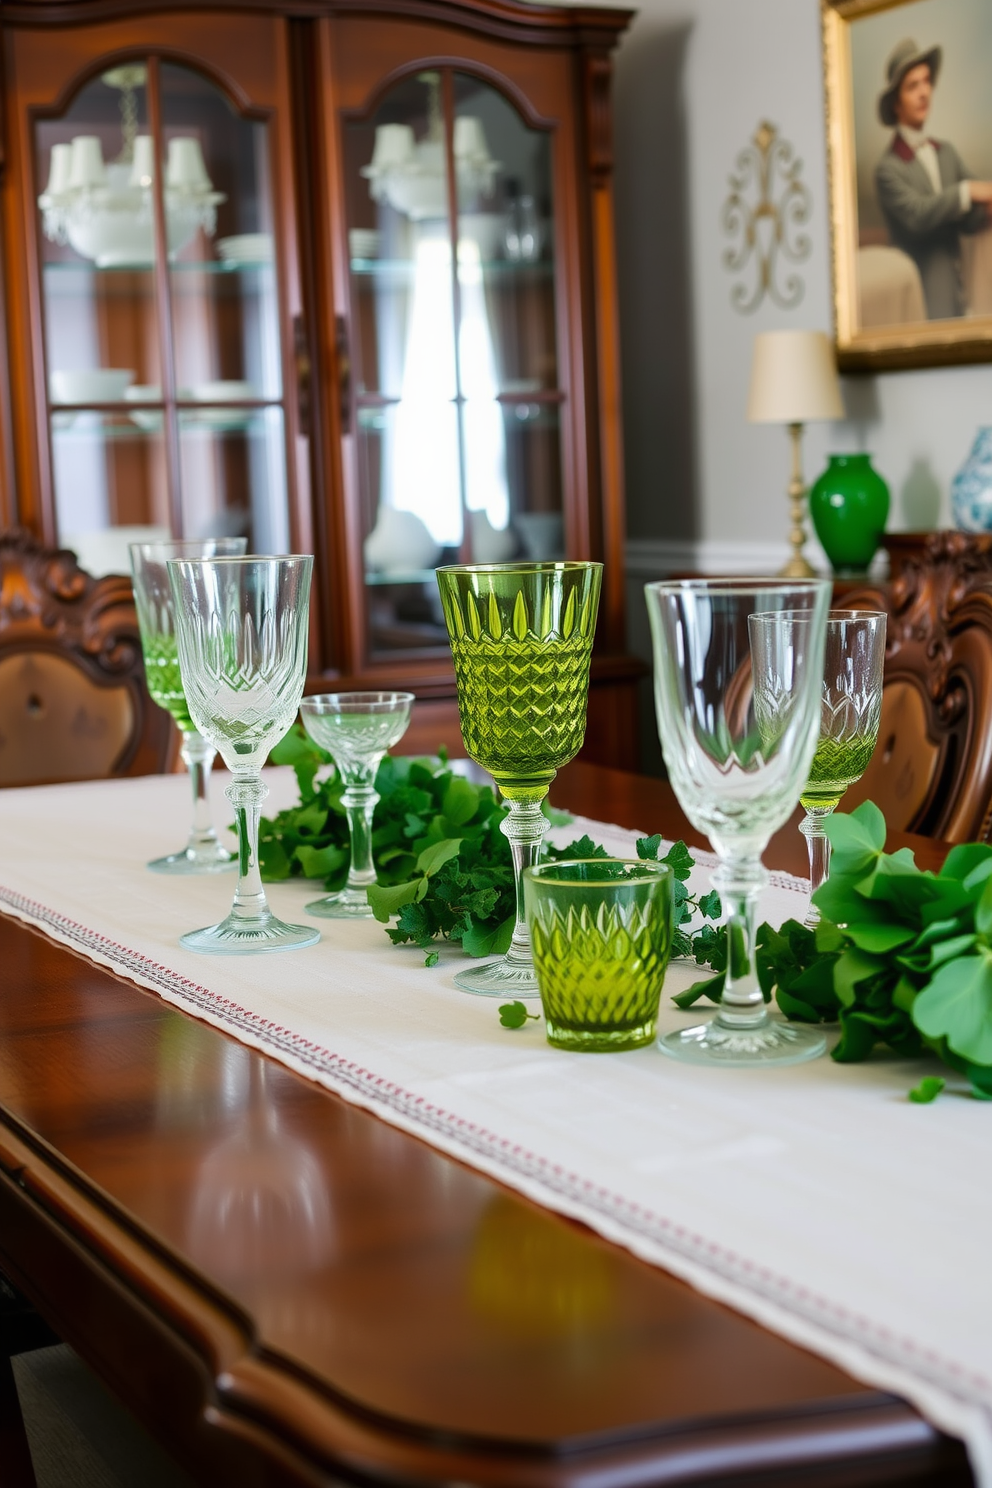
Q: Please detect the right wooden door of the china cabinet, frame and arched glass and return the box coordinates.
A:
[320,13,604,676]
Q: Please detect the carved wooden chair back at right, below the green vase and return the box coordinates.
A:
[839,533,992,842]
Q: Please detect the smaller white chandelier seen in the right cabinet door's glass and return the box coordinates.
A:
[361,73,500,222]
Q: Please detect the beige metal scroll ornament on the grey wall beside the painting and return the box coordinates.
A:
[723,119,812,315]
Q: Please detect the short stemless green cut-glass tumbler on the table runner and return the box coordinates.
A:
[524,857,674,1054]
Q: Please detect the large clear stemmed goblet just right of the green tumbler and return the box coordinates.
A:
[647,579,830,1065]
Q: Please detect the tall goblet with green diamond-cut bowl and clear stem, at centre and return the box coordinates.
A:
[437,562,602,997]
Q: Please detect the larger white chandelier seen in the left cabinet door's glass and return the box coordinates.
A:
[39,64,226,268]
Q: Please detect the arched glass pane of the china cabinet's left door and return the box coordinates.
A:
[34,57,289,573]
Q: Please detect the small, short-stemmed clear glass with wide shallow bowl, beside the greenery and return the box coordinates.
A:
[300,692,413,920]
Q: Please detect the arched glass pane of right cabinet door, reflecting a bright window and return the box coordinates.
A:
[345,68,565,658]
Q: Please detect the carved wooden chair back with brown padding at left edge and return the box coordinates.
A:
[0,531,173,786]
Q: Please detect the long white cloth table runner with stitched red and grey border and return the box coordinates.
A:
[0,771,992,1488]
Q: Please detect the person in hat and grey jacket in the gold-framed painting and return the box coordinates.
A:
[875,40,992,320]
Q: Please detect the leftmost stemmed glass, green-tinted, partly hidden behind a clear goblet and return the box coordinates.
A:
[131,537,248,873]
